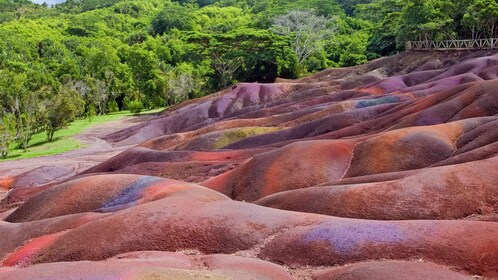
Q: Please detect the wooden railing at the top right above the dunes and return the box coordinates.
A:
[406,38,498,51]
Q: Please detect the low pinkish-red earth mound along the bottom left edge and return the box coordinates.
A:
[0,252,293,280]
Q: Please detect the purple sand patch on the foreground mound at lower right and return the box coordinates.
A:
[304,223,406,253]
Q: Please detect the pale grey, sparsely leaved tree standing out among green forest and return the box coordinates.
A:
[271,10,337,64]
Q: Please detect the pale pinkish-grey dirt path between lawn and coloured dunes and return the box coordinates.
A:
[0,112,154,184]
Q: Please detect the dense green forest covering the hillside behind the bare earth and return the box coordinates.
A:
[0,0,498,155]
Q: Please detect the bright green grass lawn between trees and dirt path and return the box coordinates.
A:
[0,108,164,161]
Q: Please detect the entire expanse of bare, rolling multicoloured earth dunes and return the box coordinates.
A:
[0,51,498,280]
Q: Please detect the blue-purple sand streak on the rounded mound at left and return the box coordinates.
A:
[96,176,160,213]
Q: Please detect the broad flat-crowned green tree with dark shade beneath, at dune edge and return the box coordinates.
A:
[195,29,298,89]
